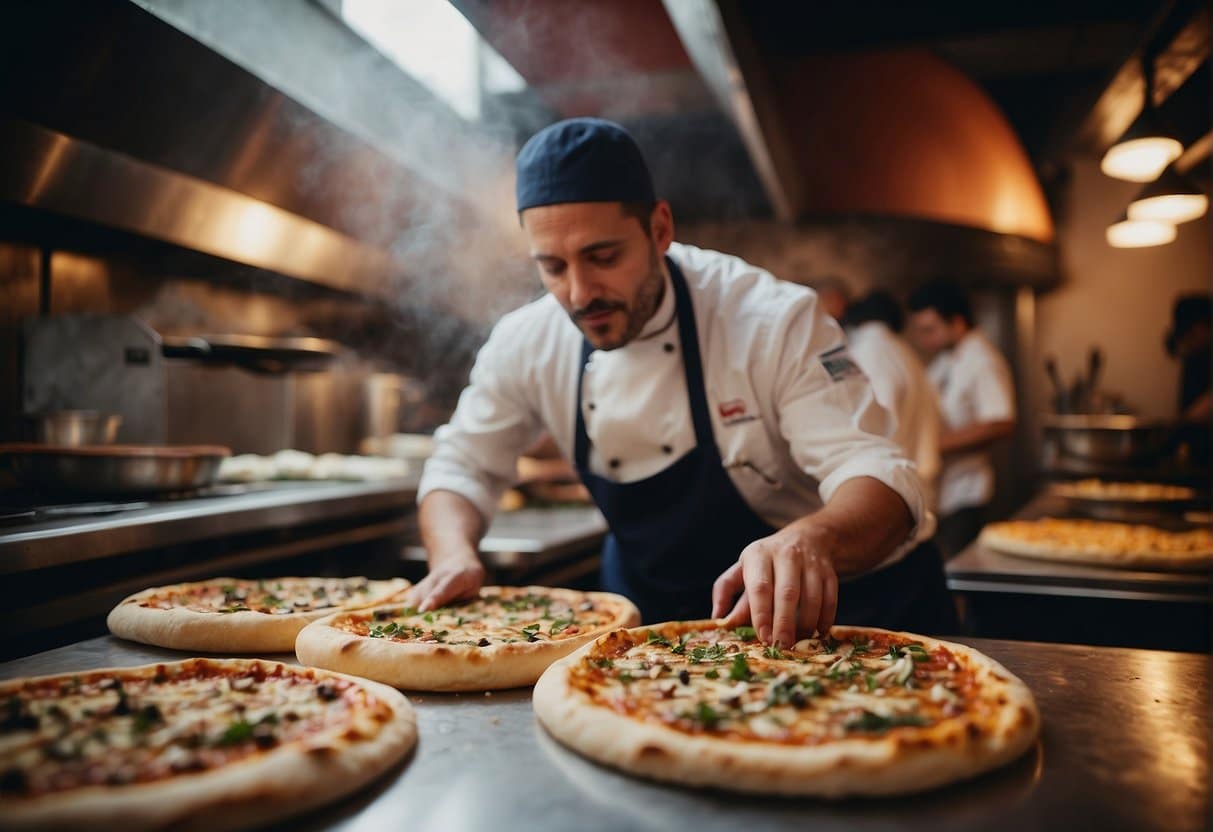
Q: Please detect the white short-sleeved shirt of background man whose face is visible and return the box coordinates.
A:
[927,330,1015,517]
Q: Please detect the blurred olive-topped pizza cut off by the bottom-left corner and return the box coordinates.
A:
[0,659,417,832]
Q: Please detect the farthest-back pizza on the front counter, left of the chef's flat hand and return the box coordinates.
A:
[106,577,410,653]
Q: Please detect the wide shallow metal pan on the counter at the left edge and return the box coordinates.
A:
[0,443,232,495]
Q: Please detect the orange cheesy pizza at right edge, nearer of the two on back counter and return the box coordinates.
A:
[979,517,1213,570]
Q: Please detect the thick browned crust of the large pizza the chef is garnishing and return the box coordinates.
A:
[533,621,1040,798]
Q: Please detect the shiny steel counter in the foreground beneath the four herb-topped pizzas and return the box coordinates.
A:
[0,638,1209,832]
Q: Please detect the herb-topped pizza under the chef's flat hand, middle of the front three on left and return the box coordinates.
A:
[295,587,640,690]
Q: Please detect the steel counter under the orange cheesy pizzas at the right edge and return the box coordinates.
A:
[945,495,1211,603]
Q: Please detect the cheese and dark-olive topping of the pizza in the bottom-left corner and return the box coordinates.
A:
[0,660,387,798]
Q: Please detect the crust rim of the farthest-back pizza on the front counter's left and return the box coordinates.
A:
[106,577,411,653]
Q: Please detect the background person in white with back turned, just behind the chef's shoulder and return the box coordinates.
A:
[845,291,941,508]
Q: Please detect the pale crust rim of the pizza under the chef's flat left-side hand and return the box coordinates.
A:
[295,587,640,691]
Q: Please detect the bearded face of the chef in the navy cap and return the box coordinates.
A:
[522,201,673,349]
